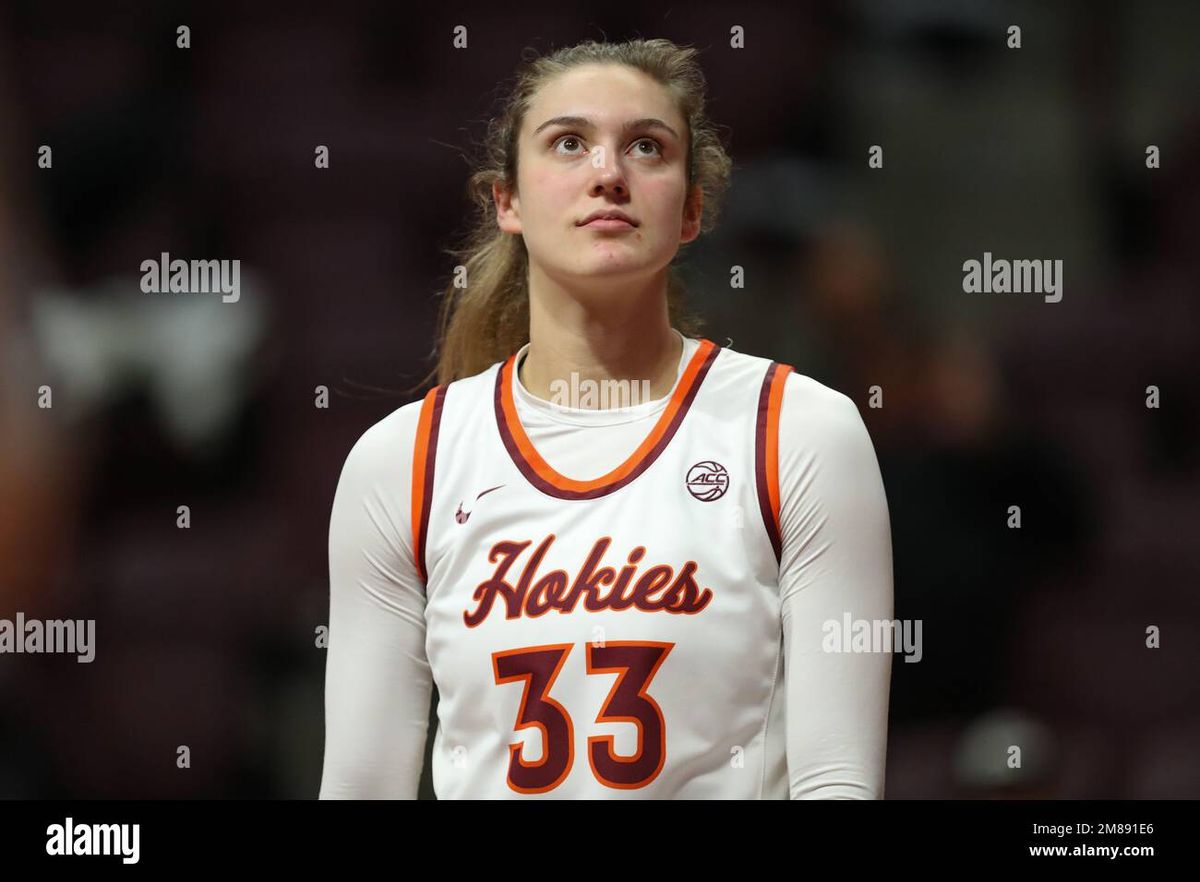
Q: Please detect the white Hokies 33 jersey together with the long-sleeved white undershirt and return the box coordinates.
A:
[322,328,892,799]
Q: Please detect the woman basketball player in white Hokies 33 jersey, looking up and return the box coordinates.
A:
[320,40,892,799]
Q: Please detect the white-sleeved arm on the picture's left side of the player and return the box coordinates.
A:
[319,401,433,799]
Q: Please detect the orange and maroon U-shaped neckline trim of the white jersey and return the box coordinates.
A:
[492,340,721,499]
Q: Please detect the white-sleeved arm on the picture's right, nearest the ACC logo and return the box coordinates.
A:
[779,372,893,799]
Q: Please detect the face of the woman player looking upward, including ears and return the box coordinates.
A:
[493,65,702,296]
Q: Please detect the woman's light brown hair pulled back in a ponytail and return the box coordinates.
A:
[416,38,732,388]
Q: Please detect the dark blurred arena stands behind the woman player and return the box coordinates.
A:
[0,0,1200,799]
